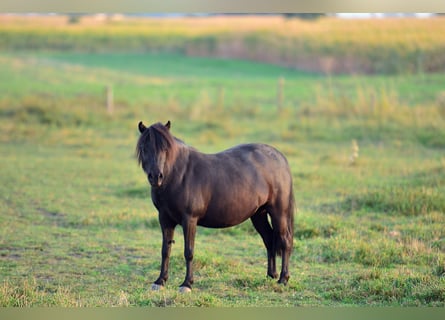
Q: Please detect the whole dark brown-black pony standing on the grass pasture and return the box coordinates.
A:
[136,121,295,292]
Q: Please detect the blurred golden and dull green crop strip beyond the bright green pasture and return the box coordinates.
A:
[0,16,445,74]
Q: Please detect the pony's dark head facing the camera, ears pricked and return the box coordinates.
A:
[136,121,175,188]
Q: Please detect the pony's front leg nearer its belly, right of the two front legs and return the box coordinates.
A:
[179,217,197,292]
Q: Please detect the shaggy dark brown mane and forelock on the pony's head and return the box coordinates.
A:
[136,122,176,164]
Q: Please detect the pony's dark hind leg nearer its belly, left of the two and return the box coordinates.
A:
[250,209,278,279]
